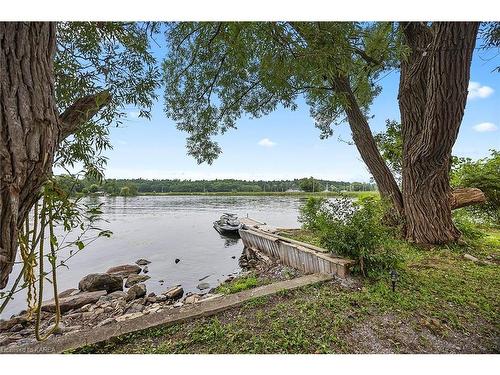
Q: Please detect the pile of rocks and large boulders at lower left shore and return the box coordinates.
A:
[0,259,218,349]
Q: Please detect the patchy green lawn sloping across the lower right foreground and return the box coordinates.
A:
[77,231,500,353]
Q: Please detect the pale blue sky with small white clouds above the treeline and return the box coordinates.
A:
[98,33,500,182]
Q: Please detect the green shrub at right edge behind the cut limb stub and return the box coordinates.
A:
[451,150,500,226]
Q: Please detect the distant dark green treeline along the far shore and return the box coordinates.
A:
[58,175,376,195]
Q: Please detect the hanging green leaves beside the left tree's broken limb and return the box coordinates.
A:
[54,22,160,181]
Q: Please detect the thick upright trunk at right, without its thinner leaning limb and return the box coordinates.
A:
[399,22,478,244]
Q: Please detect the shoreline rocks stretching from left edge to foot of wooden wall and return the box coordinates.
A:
[0,252,300,347]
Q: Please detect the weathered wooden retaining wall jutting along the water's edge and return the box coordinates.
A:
[239,227,354,277]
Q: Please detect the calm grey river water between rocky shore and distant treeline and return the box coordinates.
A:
[1,196,304,318]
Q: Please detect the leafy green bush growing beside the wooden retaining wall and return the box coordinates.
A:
[299,197,399,275]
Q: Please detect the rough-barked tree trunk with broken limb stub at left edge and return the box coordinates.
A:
[0,22,109,289]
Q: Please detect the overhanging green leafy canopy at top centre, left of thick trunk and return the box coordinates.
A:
[163,22,401,163]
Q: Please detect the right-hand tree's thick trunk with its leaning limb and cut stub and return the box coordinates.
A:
[292,22,485,243]
